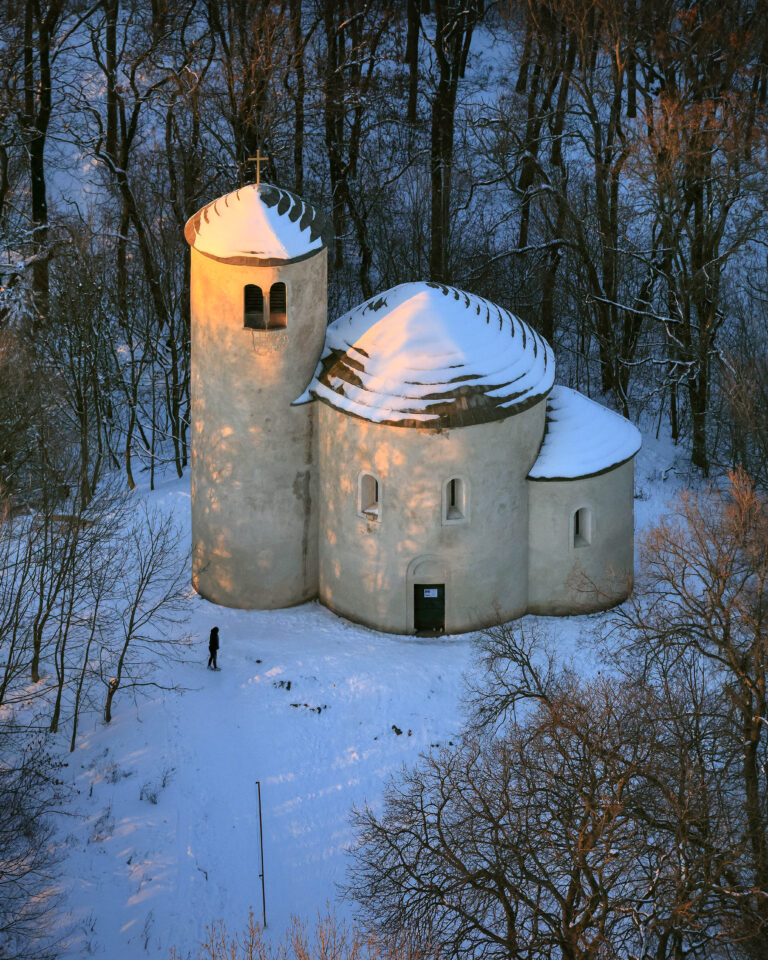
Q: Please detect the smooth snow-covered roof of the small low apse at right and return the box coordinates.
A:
[528,385,642,480]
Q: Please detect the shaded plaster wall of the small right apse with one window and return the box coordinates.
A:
[528,460,634,614]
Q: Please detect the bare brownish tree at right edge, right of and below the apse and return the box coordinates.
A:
[614,472,768,956]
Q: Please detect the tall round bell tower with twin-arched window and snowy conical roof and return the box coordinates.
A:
[189,184,327,609]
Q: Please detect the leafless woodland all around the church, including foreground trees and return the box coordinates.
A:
[0,0,768,960]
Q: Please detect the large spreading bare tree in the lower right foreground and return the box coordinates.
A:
[349,668,676,960]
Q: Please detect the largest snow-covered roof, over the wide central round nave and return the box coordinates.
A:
[297,282,555,427]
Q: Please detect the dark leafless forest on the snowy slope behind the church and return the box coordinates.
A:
[0,0,768,498]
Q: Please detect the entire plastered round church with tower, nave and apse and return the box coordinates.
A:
[185,184,640,634]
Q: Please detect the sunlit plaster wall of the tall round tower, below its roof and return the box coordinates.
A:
[191,249,327,609]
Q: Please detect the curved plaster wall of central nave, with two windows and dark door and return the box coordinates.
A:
[312,401,545,633]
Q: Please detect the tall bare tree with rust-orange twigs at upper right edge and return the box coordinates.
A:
[641,0,768,474]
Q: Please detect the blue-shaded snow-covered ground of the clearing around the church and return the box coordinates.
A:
[48,437,681,960]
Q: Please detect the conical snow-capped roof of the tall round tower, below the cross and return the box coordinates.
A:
[184,183,323,262]
